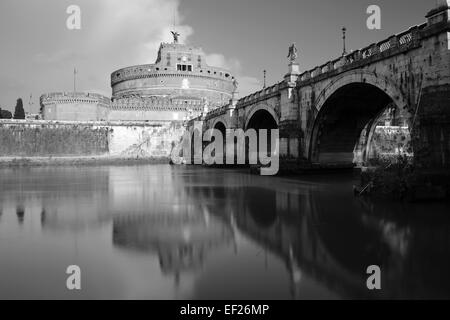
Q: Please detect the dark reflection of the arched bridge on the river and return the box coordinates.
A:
[181,174,450,299]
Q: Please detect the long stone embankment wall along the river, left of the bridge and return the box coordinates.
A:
[0,120,184,158]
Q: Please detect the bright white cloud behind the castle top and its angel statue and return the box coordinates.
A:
[87,0,262,96]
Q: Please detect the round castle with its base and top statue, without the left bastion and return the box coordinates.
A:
[109,36,235,120]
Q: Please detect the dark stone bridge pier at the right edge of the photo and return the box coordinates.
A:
[406,0,450,197]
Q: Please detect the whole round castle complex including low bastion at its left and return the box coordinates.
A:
[40,34,236,121]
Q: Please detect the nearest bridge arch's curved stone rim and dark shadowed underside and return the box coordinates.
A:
[306,71,410,166]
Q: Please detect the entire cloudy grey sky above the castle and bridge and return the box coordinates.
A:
[0,0,436,112]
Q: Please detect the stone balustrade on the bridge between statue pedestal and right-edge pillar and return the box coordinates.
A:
[299,23,427,82]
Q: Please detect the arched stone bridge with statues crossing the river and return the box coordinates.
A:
[187,0,450,169]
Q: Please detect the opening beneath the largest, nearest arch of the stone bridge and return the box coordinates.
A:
[310,83,412,168]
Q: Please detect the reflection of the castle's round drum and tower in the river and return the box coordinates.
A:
[113,208,233,276]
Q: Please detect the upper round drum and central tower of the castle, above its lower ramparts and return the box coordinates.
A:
[111,41,235,107]
